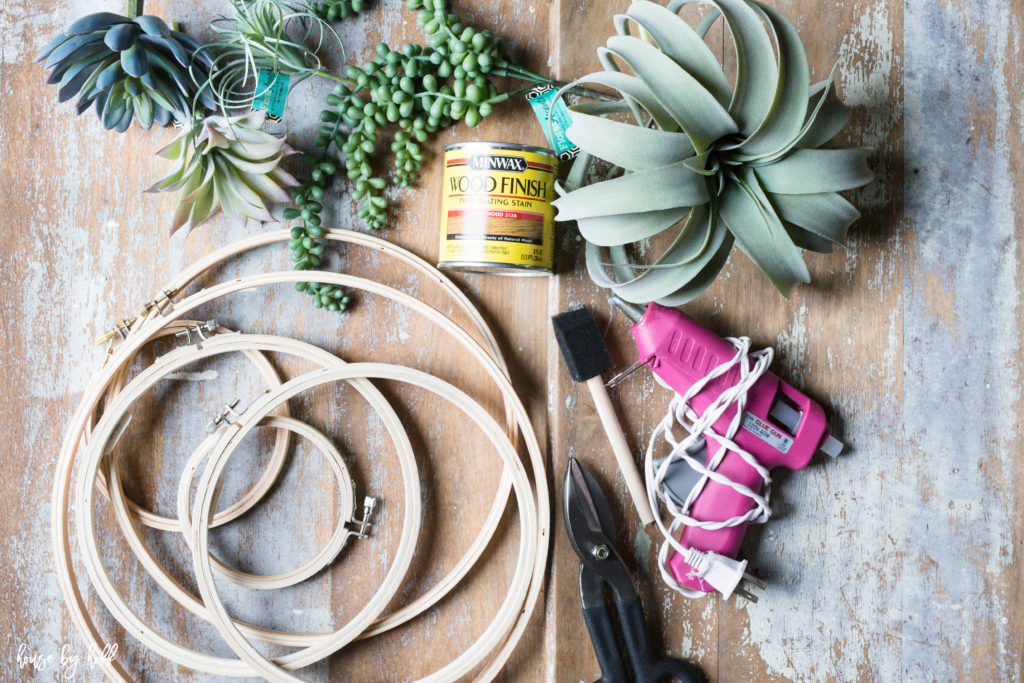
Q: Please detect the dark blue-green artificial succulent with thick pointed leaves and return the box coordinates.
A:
[39,12,215,132]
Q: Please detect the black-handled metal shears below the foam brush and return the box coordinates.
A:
[562,458,703,683]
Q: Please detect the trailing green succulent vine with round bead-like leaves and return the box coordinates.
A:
[285,0,593,310]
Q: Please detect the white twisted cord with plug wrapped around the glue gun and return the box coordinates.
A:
[644,337,774,598]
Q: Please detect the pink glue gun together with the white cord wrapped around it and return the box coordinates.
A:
[611,298,843,601]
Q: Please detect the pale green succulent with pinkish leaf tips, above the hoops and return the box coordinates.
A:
[146,112,298,232]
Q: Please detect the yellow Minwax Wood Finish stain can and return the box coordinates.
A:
[437,142,558,275]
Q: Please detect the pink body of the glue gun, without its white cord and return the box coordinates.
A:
[610,297,843,599]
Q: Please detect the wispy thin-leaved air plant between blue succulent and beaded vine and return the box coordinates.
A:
[200,0,341,112]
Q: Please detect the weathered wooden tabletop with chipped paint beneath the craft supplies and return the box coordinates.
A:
[0,0,1024,682]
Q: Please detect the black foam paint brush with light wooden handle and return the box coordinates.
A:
[551,306,654,525]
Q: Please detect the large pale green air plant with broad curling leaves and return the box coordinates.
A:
[555,0,872,305]
